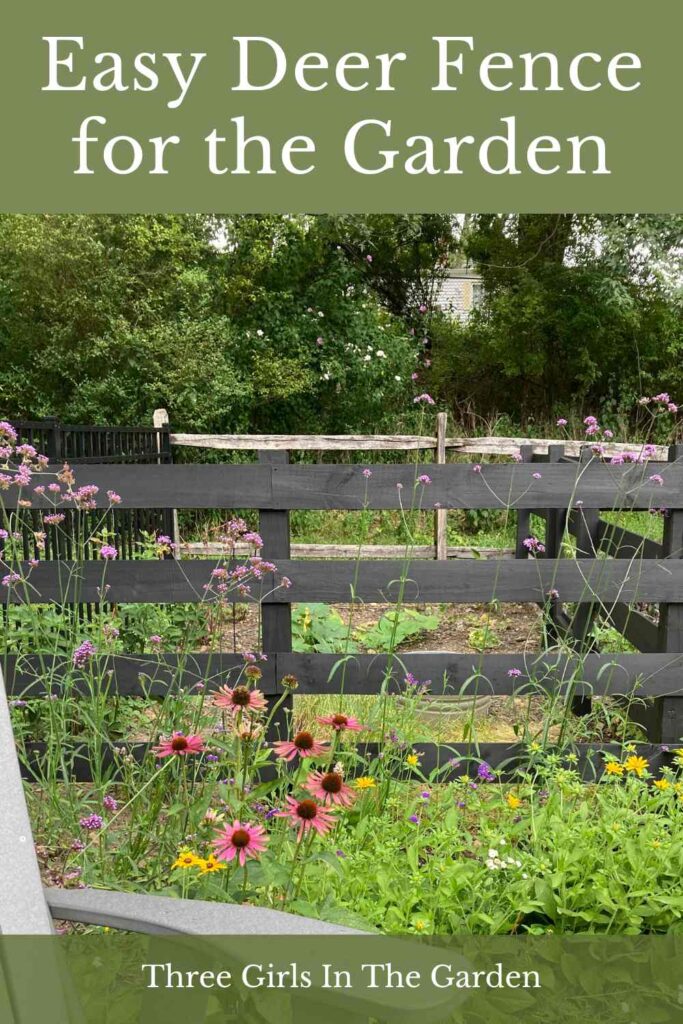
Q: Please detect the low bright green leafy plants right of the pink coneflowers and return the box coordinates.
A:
[311,755,683,935]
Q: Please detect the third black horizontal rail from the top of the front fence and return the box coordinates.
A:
[4,651,683,698]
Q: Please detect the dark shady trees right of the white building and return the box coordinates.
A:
[430,214,683,425]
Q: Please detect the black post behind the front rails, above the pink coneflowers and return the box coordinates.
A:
[258,451,293,740]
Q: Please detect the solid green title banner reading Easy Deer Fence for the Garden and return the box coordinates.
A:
[0,0,683,212]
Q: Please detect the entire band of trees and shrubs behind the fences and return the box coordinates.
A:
[0,214,683,432]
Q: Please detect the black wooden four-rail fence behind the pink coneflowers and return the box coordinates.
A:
[5,449,683,779]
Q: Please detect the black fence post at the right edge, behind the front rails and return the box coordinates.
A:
[648,444,683,743]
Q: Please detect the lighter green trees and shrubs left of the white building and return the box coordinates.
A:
[0,215,431,432]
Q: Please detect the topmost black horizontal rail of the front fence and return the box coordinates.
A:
[2,463,683,511]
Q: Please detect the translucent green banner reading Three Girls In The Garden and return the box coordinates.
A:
[0,933,683,1024]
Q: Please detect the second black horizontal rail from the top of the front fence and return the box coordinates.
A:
[9,558,683,606]
